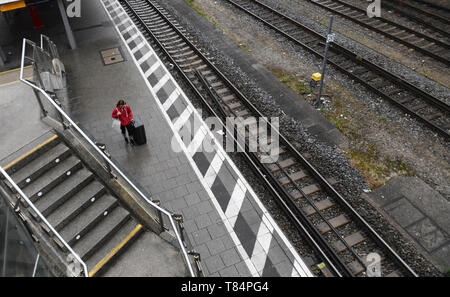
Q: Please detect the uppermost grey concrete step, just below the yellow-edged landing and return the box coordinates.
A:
[11,143,71,188]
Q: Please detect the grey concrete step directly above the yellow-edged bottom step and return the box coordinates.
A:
[72,207,131,261]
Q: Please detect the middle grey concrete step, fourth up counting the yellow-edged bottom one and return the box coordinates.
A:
[47,180,106,231]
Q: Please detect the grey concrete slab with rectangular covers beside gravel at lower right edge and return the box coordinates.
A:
[368,176,450,270]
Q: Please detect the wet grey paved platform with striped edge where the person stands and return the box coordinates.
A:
[2,0,313,277]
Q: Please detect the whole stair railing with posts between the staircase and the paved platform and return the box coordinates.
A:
[20,36,202,277]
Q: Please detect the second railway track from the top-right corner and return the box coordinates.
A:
[308,0,450,65]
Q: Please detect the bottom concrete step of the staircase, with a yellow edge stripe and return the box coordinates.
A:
[86,219,145,276]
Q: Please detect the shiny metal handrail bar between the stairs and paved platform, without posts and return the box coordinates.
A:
[20,38,195,277]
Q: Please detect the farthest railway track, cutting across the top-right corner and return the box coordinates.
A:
[383,0,450,38]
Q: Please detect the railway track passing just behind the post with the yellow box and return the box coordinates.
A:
[226,0,450,140]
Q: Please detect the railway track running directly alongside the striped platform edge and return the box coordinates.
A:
[120,0,416,276]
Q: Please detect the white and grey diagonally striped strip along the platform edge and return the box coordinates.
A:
[102,0,313,277]
